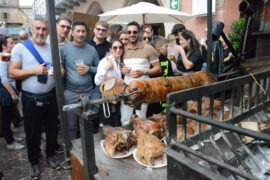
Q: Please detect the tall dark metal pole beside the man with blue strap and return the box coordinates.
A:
[46,0,71,160]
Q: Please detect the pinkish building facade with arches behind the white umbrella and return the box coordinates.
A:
[52,0,242,39]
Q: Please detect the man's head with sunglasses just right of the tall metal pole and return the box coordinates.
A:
[56,16,71,48]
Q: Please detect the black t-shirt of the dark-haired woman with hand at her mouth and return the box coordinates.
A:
[177,49,202,72]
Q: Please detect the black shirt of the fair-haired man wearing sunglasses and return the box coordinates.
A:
[85,37,110,60]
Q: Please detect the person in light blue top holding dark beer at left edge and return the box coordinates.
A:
[0,37,24,150]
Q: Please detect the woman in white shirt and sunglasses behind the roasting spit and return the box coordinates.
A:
[95,40,124,127]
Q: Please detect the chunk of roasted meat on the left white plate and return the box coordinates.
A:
[103,127,137,157]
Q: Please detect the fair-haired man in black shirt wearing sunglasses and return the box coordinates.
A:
[85,21,110,60]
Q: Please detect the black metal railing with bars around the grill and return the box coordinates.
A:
[164,71,270,179]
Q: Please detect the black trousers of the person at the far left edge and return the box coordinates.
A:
[2,104,18,144]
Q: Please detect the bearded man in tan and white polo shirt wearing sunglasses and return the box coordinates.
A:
[121,21,161,125]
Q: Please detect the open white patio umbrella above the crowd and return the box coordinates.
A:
[99,2,193,24]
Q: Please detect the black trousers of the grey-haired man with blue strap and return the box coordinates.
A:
[22,92,58,165]
